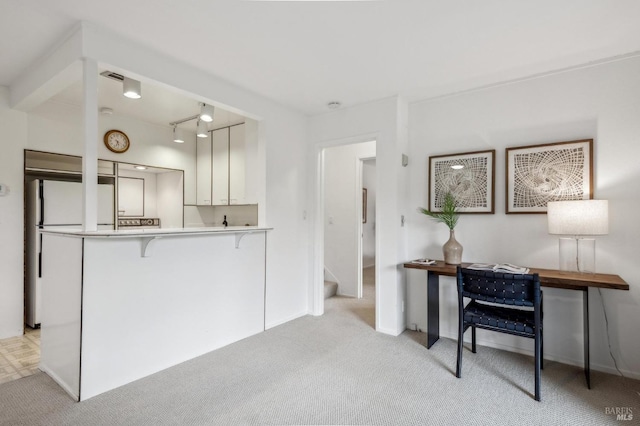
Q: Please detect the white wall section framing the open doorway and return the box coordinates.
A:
[308,98,408,335]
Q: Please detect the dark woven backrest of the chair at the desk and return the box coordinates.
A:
[457,266,540,307]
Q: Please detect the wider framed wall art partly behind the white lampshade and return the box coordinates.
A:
[505,139,593,213]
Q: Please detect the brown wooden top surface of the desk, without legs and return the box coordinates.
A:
[404,260,629,290]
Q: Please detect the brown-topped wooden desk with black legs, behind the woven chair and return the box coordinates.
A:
[404,260,629,389]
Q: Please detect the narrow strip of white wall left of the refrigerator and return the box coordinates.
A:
[0,86,27,339]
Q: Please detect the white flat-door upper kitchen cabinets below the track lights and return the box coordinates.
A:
[196,123,258,206]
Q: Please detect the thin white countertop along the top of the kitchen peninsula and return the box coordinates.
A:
[40,226,273,238]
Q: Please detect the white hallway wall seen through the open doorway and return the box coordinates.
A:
[324,142,376,297]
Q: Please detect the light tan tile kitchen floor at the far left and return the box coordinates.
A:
[0,327,40,384]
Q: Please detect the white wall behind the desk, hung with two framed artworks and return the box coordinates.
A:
[407,58,640,378]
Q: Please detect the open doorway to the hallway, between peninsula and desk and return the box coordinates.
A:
[320,141,376,318]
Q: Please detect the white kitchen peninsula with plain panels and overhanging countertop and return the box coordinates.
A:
[40,227,269,401]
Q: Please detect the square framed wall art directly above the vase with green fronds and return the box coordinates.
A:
[429,149,496,213]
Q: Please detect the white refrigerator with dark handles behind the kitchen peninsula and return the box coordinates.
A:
[25,179,114,328]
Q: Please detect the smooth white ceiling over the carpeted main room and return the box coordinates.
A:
[0,0,640,119]
